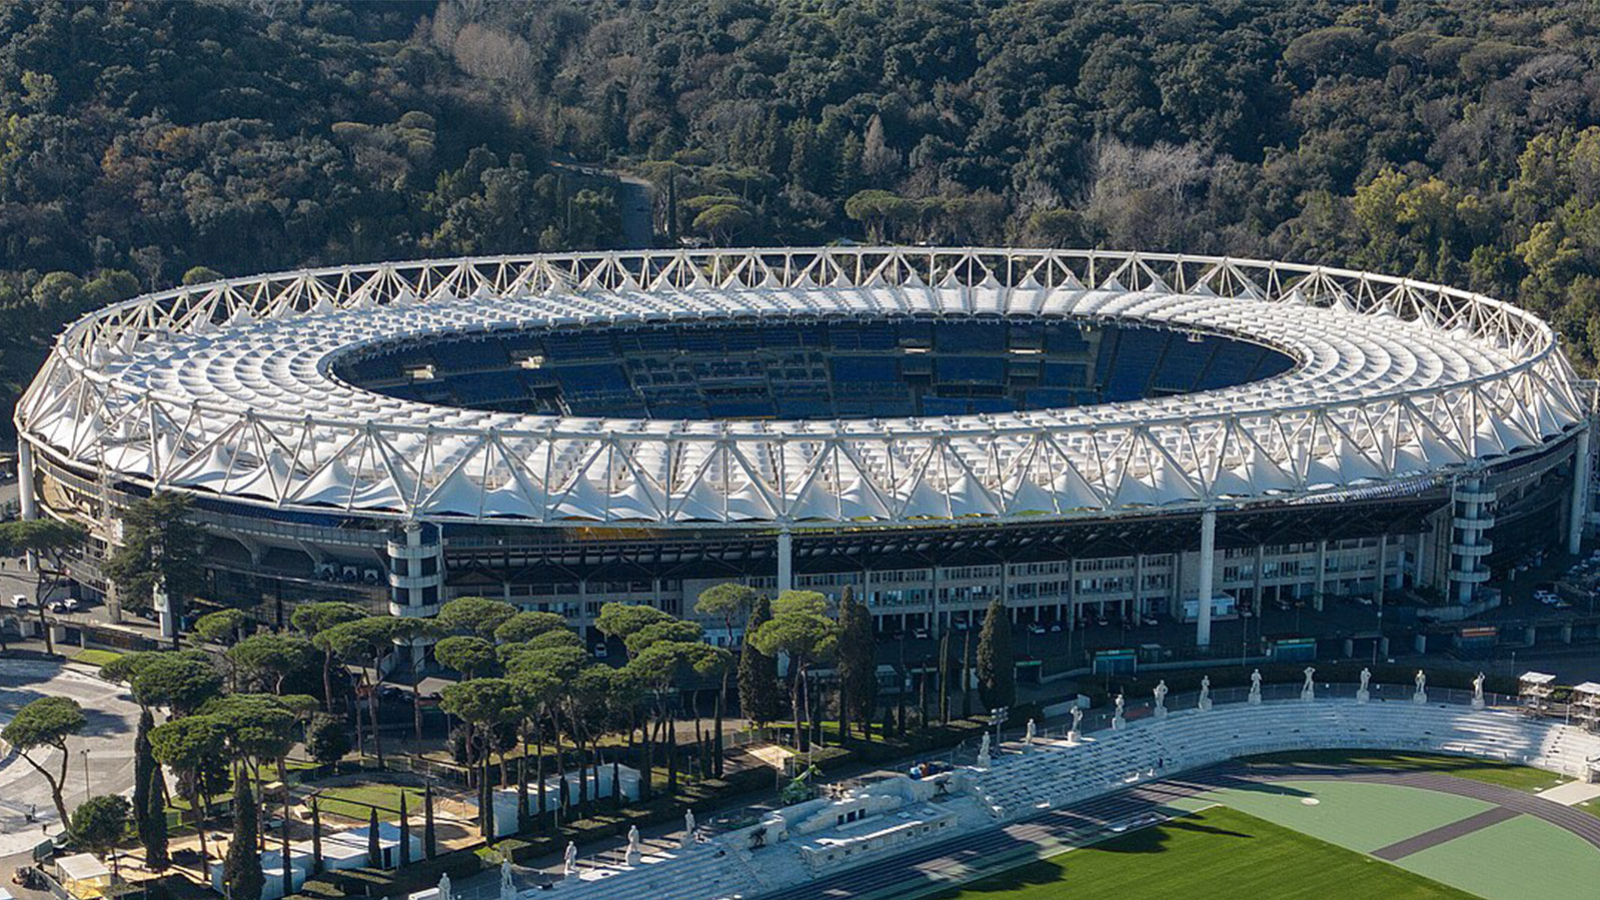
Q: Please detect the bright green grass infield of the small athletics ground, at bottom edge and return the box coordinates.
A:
[933,807,1472,900]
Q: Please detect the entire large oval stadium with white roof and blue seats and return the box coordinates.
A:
[16,248,1592,656]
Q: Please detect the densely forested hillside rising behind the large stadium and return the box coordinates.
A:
[0,0,1600,416]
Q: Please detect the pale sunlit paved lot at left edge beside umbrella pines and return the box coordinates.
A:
[0,650,139,857]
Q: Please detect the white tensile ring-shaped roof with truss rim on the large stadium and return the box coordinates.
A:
[18,248,1584,527]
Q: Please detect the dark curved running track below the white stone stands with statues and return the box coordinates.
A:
[760,762,1600,900]
